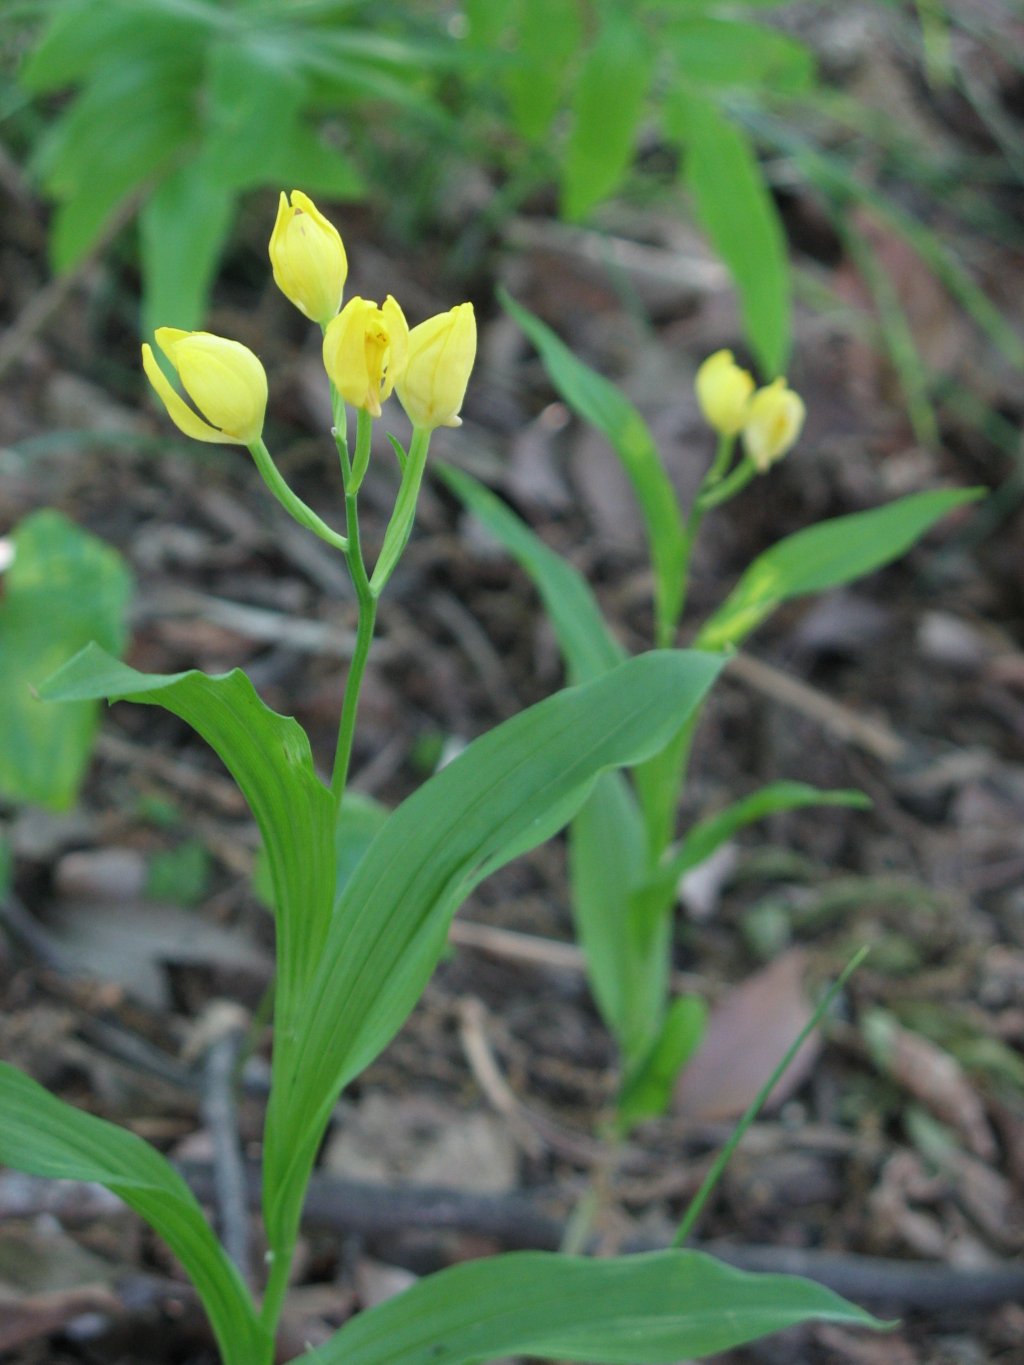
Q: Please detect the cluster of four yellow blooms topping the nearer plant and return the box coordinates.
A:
[142,190,477,445]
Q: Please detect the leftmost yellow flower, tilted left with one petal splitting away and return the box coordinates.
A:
[142,328,266,445]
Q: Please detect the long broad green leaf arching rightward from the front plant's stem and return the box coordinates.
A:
[265,651,721,1242]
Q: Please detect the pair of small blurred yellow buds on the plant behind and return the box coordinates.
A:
[695,351,806,474]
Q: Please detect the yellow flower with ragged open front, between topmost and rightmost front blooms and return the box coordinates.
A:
[324,295,410,418]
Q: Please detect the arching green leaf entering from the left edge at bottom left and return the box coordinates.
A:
[0,1062,269,1365]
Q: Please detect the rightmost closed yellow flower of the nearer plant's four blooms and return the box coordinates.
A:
[397,303,477,431]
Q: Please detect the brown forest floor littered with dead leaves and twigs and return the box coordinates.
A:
[0,5,1024,1365]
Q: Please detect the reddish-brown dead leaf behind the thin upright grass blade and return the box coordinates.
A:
[676,949,821,1123]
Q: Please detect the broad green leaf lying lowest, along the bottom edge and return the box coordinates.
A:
[309,1252,885,1365]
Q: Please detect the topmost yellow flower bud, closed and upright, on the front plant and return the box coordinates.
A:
[270,190,348,326]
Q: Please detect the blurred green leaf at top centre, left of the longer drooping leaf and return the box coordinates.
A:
[561,7,653,220]
